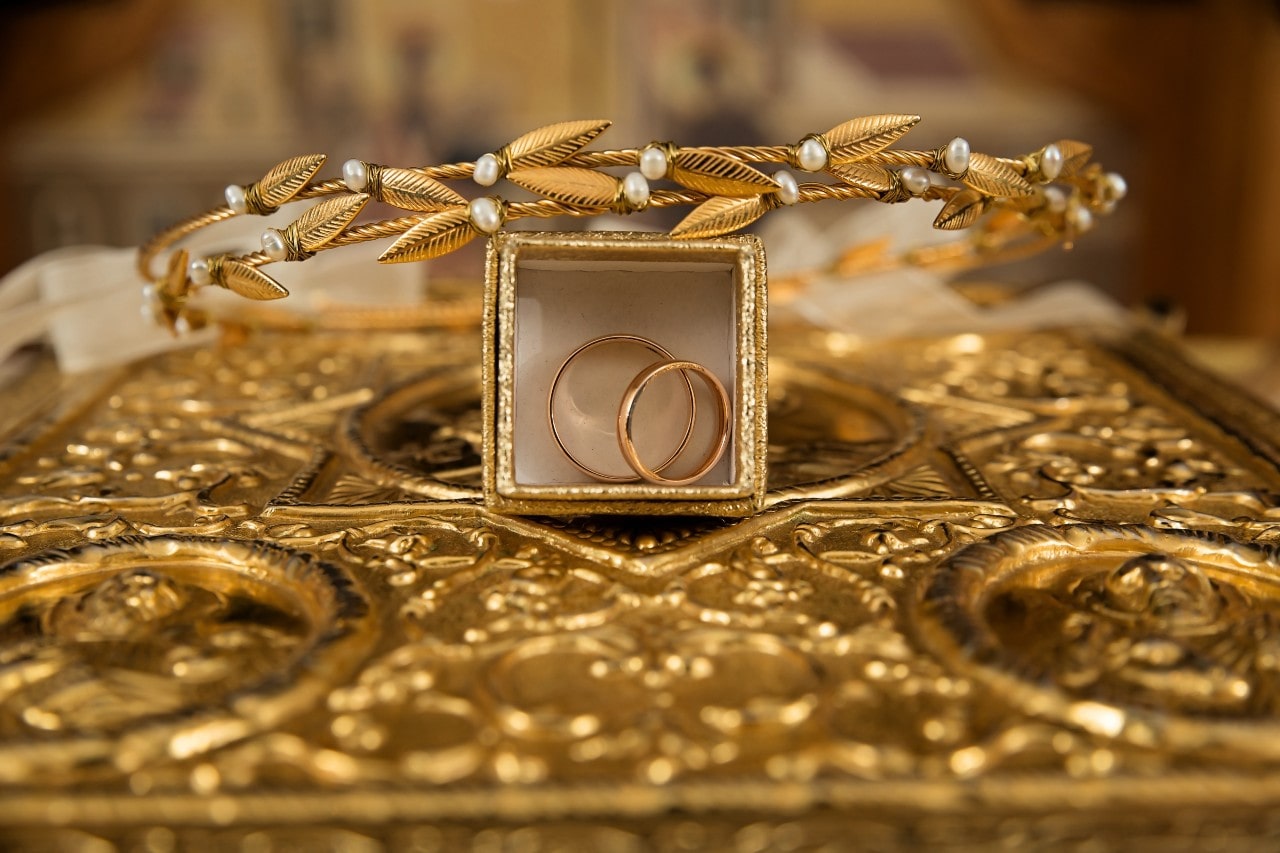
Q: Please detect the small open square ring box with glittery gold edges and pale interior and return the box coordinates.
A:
[483,232,767,516]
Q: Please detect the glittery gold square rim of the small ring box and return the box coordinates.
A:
[481,232,769,516]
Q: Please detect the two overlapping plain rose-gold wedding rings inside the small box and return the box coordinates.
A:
[547,334,732,485]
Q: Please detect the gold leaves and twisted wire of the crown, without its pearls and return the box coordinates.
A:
[138,115,1124,333]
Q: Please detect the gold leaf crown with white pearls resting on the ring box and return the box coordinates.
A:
[138,114,1125,330]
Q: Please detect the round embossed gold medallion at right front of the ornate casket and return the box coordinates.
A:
[923,525,1280,760]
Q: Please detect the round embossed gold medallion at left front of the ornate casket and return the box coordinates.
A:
[0,537,371,784]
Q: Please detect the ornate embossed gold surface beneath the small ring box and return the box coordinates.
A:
[0,320,1280,850]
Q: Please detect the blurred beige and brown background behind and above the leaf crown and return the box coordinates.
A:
[0,0,1280,336]
